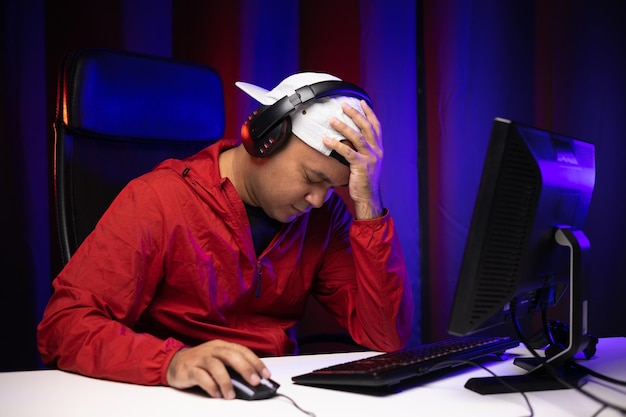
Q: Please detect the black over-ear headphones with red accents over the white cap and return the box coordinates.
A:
[241,81,372,158]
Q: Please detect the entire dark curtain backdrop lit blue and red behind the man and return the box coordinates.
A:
[0,0,626,369]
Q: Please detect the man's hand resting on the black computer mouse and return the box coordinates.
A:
[167,340,270,400]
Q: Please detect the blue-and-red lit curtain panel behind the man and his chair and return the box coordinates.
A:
[0,0,420,370]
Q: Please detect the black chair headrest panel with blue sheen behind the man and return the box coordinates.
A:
[57,48,225,140]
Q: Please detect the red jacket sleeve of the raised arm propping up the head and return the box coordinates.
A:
[314,205,413,352]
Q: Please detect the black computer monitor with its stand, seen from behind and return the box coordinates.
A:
[448,118,595,393]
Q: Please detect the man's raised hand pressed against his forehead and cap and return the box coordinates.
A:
[324,100,383,220]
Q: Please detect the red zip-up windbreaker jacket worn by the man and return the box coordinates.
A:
[38,141,413,385]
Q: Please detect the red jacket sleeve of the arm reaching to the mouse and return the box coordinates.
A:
[38,176,183,385]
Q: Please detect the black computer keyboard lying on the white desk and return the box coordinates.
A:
[292,336,519,394]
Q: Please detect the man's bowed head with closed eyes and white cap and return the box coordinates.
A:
[228,73,369,223]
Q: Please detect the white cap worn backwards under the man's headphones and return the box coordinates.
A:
[235,72,363,155]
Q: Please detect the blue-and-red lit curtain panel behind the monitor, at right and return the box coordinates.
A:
[420,0,626,339]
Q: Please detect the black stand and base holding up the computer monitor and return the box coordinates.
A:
[465,227,590,394]
